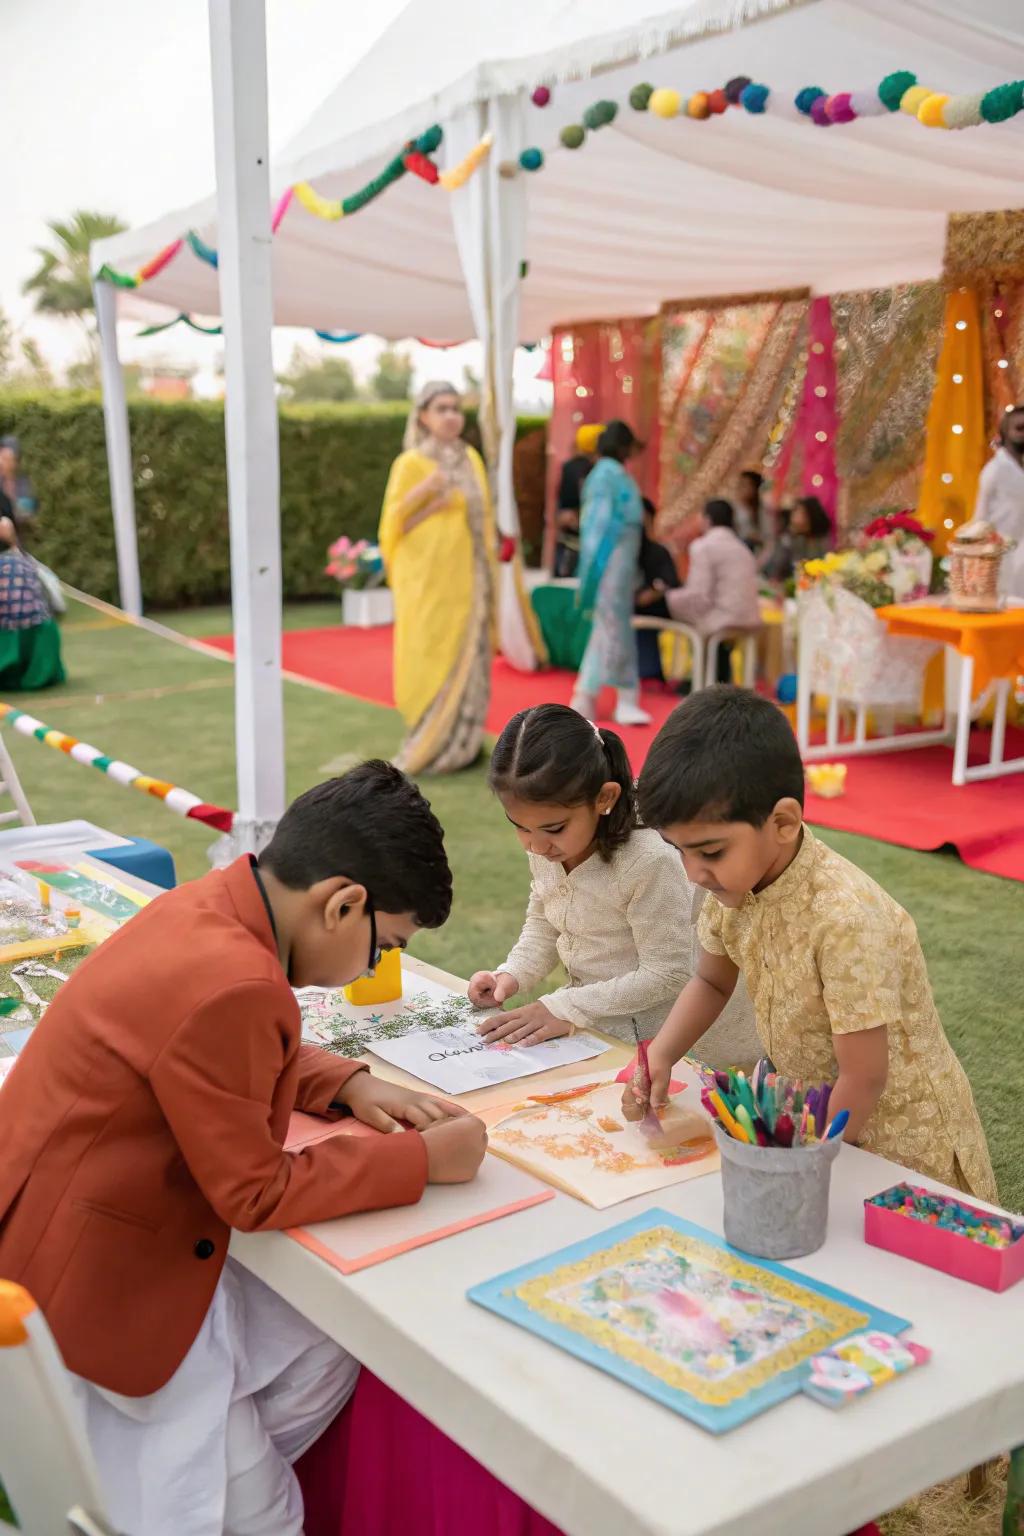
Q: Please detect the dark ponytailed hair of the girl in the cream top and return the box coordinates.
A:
[488,703,637,860]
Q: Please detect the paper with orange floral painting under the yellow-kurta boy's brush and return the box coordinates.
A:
[484,1075,720,1210]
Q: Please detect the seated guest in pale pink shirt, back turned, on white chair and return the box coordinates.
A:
[665,501,761,682]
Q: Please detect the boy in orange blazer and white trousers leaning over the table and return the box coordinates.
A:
[0,762,487,1536]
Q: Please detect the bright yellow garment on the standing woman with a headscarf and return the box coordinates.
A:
[379,449,496,728]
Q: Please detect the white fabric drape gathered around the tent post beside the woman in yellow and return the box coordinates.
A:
[445,95,542,671]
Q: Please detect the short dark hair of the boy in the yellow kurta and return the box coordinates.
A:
[639,684,803,828]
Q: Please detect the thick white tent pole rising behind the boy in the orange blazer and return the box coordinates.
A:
[209,0,284,854]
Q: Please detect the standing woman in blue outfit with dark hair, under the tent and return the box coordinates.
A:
[573,421,651,725]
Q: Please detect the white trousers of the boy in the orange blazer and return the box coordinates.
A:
[72,1260,359,1536]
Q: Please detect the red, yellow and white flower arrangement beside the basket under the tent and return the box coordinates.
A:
[798,511,933,608]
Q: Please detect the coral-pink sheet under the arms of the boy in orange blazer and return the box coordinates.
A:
[284,1114,554,1275]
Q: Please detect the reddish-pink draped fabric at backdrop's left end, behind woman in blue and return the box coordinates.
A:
[545,319,662,565]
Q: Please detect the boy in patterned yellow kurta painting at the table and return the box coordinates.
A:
[623,688,996,1201]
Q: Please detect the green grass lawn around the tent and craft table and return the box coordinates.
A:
[0,604,1024,1531]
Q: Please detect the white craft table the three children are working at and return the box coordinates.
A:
[232,960,1024,1536]
